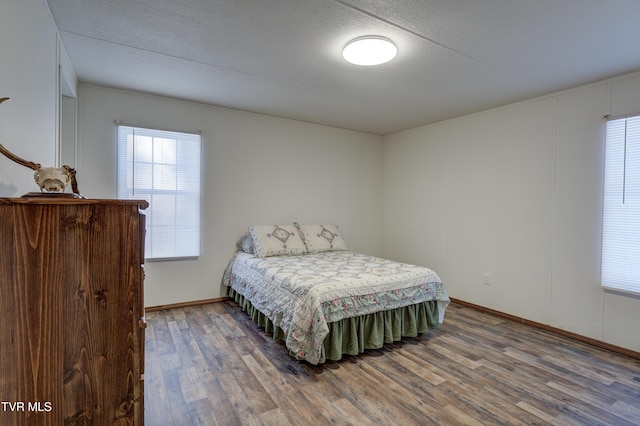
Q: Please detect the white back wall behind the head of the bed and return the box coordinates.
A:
[76,84,382,306]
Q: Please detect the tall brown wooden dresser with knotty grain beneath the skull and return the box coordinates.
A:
[0,196,148,426]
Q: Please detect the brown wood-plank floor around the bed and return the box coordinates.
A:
[145,301,640,426]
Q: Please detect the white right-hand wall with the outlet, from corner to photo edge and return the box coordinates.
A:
[383,74,640,351]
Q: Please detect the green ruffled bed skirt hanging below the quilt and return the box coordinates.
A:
[229,287,438,363]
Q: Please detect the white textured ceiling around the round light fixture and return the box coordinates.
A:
[48,0,640,134]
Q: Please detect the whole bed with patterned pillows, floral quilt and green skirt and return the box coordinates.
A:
[223,224,449,364]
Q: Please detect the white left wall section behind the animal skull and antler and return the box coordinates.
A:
[0,0,67,197]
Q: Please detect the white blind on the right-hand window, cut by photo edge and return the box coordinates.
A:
[602,116,640,294]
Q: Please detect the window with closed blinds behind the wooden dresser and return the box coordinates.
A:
[118,126,200,260]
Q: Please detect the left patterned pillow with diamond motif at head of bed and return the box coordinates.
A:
[249,225,307,257]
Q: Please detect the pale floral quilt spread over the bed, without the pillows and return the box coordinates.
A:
[223,251,449,364]
